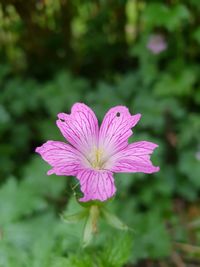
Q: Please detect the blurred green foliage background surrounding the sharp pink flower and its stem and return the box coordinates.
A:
[0,0,200,267]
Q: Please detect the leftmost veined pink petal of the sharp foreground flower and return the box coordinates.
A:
[36,141,82,175]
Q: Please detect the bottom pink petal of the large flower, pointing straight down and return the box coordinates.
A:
[77,169,116,202]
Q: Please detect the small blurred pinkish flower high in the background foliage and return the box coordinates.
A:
[147,34,167,54]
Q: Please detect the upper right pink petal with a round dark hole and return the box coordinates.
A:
[99,106,141,158]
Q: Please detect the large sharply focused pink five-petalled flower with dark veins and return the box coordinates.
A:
[36,103,159,202]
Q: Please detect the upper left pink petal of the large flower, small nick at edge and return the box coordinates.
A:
[57,103,99,155]
